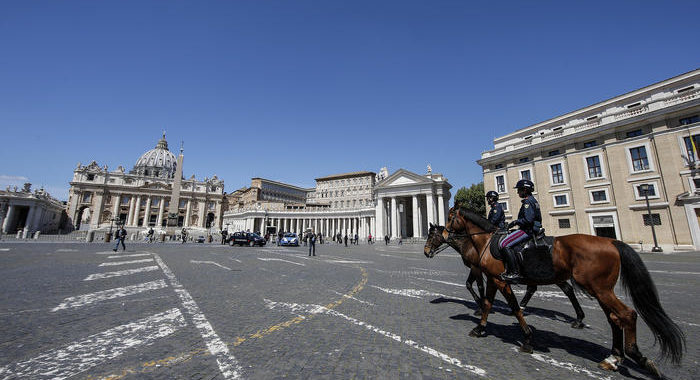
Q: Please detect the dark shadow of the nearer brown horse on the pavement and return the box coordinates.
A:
[450,314,648,380]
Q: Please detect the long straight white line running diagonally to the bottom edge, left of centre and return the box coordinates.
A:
[153,253,243,379]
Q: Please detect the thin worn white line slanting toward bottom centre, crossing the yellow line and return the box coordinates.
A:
[265,299,486,376]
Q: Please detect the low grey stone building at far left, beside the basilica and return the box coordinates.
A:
[0,183,66,238]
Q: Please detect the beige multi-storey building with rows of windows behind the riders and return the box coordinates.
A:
[477,69,700,252]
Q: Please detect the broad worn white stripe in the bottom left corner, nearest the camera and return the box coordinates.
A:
[0,308,186,379]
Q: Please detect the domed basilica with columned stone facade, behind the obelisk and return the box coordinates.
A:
[68,134,225,231]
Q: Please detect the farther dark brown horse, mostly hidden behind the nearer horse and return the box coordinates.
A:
[423,223,585,329]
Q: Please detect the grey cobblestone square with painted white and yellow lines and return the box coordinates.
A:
[0,242,700,379]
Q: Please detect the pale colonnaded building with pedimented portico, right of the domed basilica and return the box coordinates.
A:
[224,168,452,239]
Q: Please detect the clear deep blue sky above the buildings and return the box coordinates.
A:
[0,0,700,199]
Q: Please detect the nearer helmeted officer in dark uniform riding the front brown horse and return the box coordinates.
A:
[500,179,542,282]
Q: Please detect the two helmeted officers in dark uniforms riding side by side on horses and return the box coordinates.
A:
[486,179,542,283]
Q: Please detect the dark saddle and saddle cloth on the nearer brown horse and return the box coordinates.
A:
[489,228,555,282]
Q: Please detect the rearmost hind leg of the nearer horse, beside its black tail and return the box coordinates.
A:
[598,290,663,379]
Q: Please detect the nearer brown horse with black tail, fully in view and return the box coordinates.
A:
[426,207,685,378]
